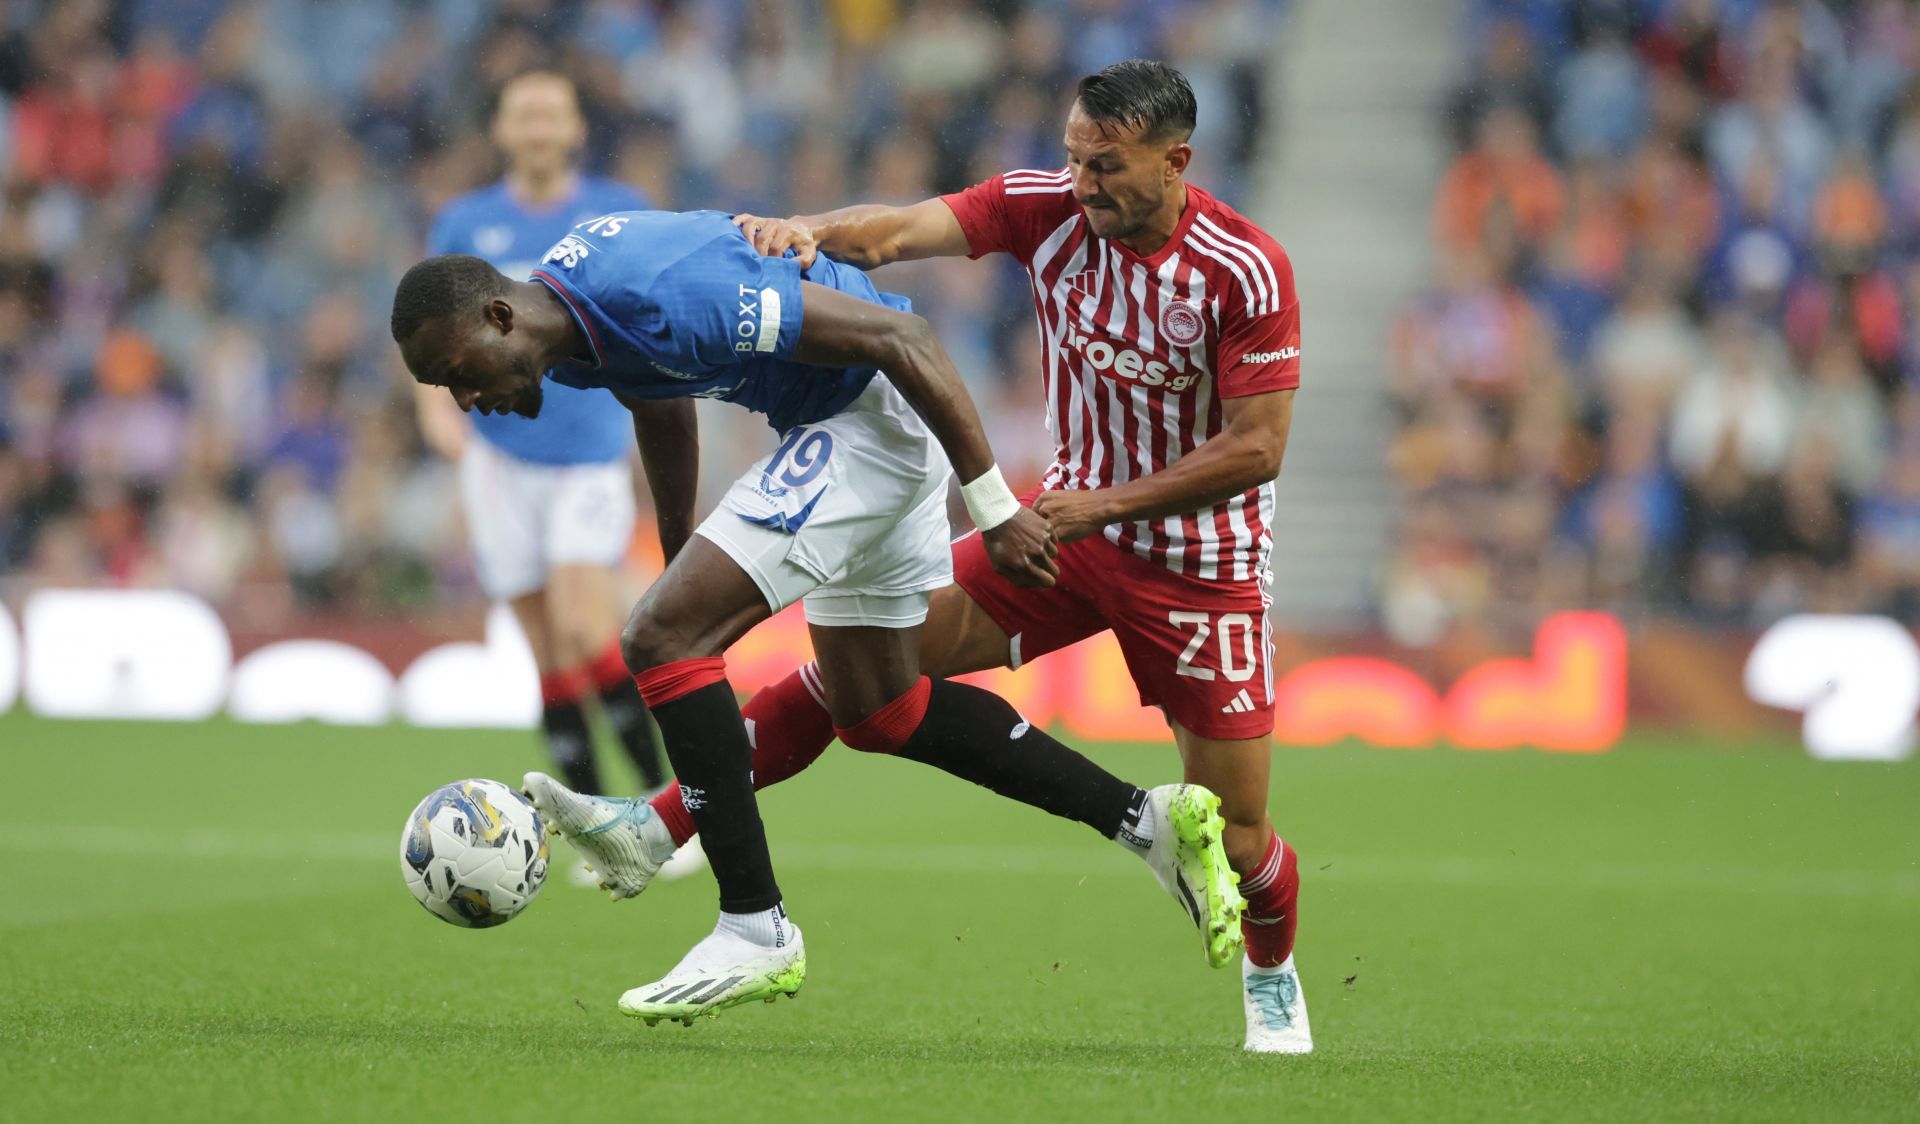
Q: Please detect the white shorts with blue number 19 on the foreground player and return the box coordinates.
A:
[697,375,952,628]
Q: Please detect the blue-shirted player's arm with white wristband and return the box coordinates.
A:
[793,281,1060,588]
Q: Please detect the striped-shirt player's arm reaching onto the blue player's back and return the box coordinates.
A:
[733,200,970,269]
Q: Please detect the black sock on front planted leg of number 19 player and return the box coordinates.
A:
[653,678,780,913]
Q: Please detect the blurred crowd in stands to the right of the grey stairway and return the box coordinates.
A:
[1382,0,1920,642]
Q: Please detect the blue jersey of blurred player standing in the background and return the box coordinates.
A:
[426,175,647,465]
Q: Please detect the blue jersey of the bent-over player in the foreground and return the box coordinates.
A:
[534,211,912,432]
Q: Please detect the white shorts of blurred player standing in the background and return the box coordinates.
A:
[461,434,634,599]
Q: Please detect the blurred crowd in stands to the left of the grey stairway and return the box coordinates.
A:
[0,0,1277,626]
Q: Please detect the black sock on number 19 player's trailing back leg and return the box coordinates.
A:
[897,678,1146,840]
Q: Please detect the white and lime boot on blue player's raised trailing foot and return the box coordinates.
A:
[1146,784,1246,968]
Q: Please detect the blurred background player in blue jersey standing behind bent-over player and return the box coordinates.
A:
[417,71,666,806]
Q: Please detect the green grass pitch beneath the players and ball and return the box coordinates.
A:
[0,713,1920,1124]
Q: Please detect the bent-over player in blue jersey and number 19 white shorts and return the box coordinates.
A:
[392,211,1240,1022]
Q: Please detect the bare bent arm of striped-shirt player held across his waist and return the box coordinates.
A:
[1033,390,1294,542]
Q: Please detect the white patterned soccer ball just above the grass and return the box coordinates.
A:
[399,780,547,928]
